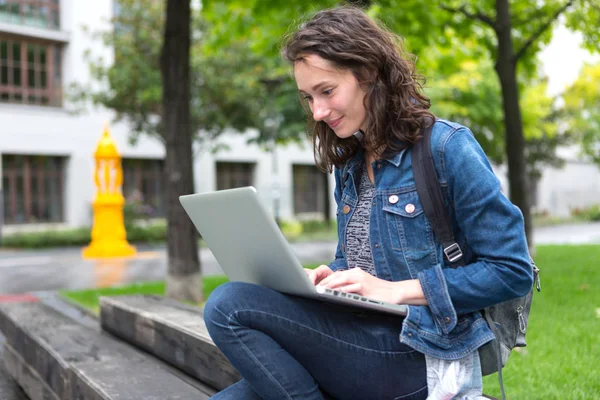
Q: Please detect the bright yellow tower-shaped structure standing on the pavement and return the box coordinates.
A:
[83,124,136,258]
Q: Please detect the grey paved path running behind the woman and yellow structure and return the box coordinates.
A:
[0,222,600,295]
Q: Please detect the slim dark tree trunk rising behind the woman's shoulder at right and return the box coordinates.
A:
[496,0,533,248]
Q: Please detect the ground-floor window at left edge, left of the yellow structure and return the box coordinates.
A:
[2,154,66,224]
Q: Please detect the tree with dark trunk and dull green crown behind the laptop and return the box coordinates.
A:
[69,0,305,300]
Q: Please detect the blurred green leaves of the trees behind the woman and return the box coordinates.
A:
[70,0,600,167]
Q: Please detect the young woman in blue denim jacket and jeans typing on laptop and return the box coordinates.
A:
[204,7,533,400]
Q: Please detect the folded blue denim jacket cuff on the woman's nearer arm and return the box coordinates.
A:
[417,264,457,334]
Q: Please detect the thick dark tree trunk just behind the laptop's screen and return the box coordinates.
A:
[161,0,202,302]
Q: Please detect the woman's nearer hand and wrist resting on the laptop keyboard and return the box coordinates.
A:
[319,268,427,305]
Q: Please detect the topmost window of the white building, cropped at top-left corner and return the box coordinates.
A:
[0,0,60,29]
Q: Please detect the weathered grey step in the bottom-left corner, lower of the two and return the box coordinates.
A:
[0,303,213,400]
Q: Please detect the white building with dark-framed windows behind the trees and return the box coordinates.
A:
[0,0,333,233]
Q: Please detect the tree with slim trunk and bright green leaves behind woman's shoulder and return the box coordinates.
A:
[225,0,600,243]
